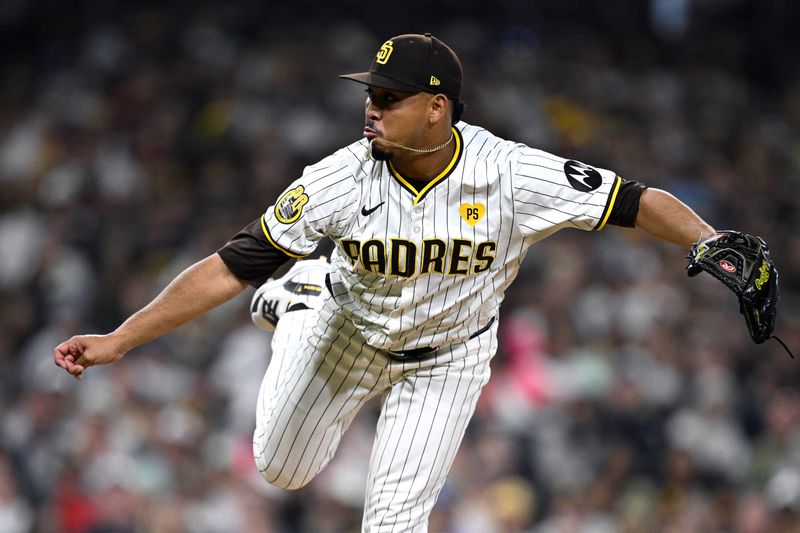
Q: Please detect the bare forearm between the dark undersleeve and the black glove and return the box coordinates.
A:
[636,188,716,250]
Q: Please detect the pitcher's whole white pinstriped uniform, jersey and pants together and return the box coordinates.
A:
[253,122,619,532]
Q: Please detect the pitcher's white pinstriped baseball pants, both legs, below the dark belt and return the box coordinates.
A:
[253,294,497,532]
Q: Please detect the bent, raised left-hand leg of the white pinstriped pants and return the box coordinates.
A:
[253,302,389,489]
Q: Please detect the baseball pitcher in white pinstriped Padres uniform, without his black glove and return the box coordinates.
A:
[55,34,777,532]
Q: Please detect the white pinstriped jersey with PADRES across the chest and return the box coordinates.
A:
[262,122,621,351]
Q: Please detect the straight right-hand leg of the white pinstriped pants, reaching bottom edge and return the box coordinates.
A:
[363,325,497,533]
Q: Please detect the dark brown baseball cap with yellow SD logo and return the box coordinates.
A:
[339,33,463,100]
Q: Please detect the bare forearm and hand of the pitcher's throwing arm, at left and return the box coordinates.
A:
[54,253,248,379]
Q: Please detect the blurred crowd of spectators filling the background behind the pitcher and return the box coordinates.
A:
[0,0,800,533]
